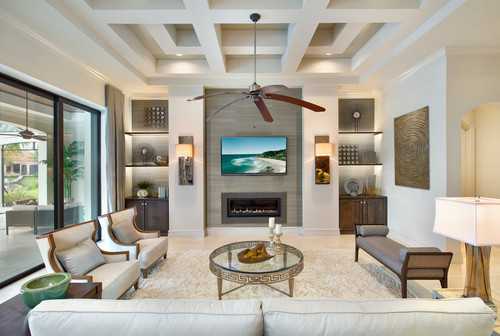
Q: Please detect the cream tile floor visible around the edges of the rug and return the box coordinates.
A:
[0,232,500,303]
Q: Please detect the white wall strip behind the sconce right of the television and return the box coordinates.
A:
[302,85,339,236]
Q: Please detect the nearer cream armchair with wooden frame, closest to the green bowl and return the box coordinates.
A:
[36,220,140,299]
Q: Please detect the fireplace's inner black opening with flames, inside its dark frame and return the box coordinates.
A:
[227,198,281,217]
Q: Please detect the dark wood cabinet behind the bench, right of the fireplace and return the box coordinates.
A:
[339,195,387,234]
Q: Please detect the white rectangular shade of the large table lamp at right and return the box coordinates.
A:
[433,197,500,246]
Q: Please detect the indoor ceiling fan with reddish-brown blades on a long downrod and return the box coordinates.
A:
[188,13,325,122]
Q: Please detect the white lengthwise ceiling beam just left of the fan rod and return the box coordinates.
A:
[184,0,226,73]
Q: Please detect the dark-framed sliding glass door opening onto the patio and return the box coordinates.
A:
[0,74,100,288]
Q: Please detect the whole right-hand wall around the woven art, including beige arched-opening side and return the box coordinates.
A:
[380,48,500,251]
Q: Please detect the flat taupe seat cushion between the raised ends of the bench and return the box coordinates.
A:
[356,236,404,275]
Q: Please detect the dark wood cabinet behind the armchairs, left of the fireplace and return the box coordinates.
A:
[125,197,168,236]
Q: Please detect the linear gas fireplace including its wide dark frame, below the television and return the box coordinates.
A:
[221,192,286,224]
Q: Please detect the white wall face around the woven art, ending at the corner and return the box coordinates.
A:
[377,55,446,249]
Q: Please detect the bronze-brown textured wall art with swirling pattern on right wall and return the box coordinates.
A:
[394,106,429,189]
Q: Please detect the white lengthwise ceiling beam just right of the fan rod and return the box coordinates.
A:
[282,0,329,73]
